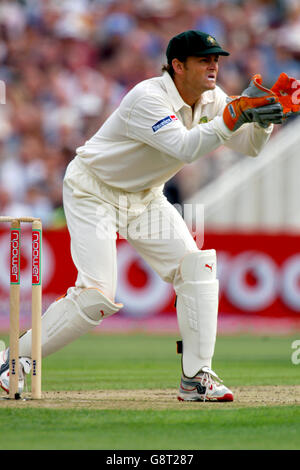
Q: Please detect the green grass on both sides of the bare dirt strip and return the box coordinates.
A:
[0,334,300,450]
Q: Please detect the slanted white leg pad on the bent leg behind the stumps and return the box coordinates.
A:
[19,287,123,357]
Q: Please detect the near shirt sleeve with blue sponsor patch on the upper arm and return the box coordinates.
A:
[127,95,233,163]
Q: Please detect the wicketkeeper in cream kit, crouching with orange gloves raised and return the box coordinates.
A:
[0,31,299,401]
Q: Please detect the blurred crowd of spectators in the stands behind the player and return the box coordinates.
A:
[0,0,300,227]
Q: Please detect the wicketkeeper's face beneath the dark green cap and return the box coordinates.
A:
[178,54,219,94]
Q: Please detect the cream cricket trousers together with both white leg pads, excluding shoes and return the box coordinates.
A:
[20,157,218,377]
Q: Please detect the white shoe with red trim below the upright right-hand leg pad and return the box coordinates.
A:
[177,367,233,401]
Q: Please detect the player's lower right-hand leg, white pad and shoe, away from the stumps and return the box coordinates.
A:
[176,250,233,401]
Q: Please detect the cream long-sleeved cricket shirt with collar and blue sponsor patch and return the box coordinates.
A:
[77,72,273,192]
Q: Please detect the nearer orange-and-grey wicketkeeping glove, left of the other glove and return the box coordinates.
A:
[223,75,283,131]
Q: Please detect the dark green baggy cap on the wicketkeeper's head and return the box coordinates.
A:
[166,30,230,64]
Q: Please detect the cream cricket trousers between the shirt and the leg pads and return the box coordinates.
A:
[63,157,198,300]
